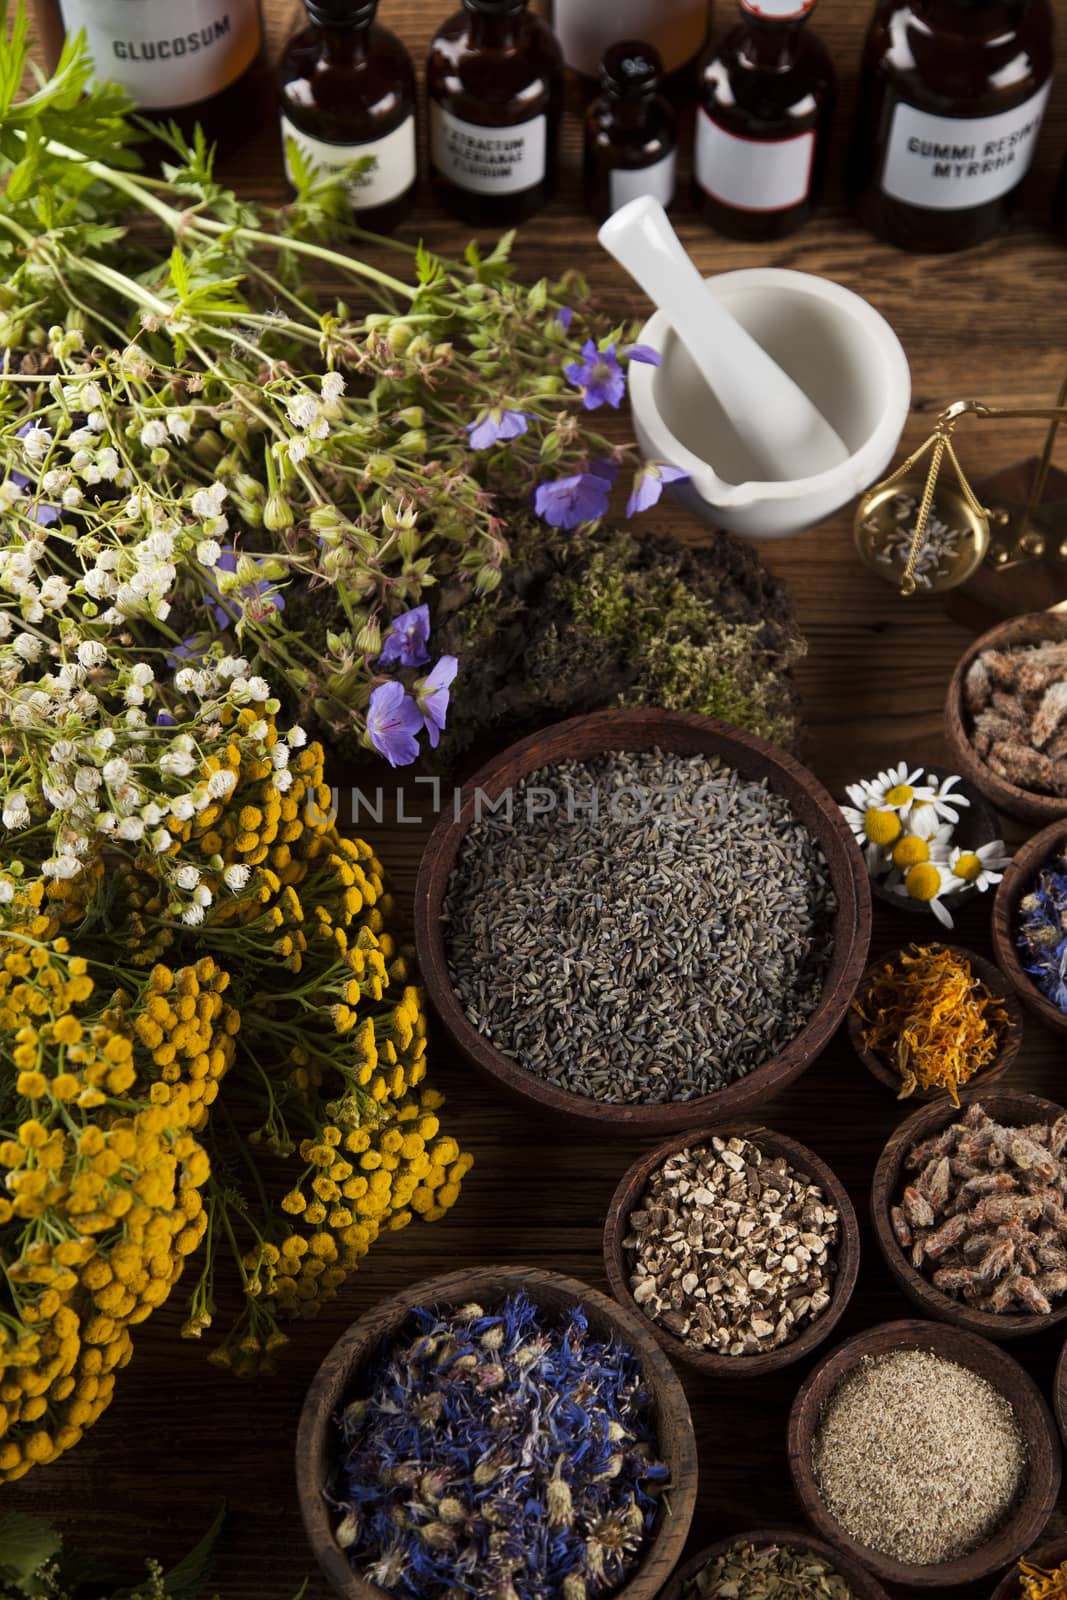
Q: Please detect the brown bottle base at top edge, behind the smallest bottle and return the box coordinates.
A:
[552,0,710,78]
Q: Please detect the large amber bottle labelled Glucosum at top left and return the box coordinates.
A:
[37,0,272,154]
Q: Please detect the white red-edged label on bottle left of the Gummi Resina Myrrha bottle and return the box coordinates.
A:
[693,107,816,211]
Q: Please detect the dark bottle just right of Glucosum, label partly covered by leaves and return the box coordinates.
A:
[278,0,418,234]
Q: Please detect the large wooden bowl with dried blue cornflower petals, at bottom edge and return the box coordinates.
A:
[296,1267,697,1600]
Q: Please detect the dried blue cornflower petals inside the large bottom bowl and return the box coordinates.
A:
[331,1294,669,1600]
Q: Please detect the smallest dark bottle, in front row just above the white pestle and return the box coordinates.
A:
[582,38,678,222]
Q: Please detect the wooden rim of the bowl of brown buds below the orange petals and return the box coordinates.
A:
[870,1088,1067,1342]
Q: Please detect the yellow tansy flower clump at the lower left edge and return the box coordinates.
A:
[0,940,238,1480]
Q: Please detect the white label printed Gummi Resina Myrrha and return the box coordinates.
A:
[881,83,1051,211]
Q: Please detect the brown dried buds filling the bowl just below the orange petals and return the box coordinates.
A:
[891,1104,1067,1315]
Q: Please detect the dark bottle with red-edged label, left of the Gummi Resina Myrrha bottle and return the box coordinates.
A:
[693,0,837,240]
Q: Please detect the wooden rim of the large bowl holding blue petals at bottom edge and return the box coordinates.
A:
[296,1267,697,1600]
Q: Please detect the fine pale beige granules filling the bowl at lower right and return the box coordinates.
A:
[811,1349,1027,1566]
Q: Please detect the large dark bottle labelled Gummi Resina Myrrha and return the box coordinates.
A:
[848,0,1053,251]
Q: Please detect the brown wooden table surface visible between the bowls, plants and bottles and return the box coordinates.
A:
[16,0,1067,1600]
